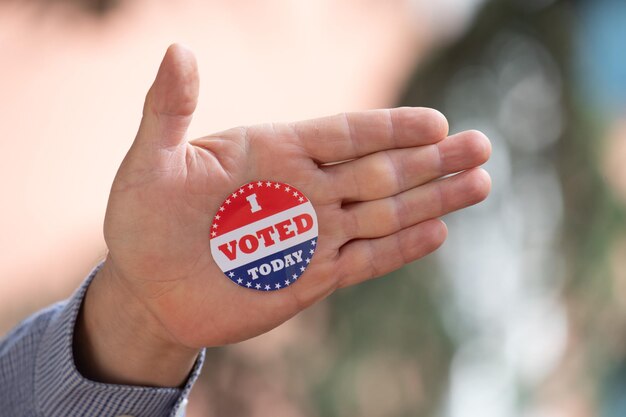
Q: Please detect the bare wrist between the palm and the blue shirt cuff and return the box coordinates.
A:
[74,258,199,387]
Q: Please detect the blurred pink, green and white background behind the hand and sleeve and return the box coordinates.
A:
[0,0,626,417]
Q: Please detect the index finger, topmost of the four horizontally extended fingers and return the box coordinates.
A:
[291,107,448,163]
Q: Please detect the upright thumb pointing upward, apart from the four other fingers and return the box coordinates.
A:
[135,44,199,150]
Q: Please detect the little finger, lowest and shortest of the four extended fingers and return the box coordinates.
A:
[337,219,448,288]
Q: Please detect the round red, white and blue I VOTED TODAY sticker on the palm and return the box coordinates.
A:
[210,181,317,291]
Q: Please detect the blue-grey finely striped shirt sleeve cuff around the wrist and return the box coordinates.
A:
[0,268,204,417]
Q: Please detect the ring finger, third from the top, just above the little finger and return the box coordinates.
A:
[343,168,491,240]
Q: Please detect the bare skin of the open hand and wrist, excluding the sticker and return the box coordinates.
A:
[74,45,491,387]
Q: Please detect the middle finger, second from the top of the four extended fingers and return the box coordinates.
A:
[323,130,491,201]
